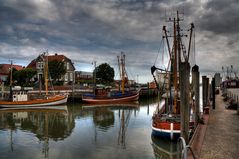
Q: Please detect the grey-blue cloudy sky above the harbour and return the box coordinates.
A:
[0,0,239,82]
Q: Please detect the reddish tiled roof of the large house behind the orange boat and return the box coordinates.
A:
[27,54,75,69]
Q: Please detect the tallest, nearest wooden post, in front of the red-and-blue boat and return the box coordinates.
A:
[179,62,190,144]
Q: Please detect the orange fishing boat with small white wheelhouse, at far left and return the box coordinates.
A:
[0,53,68,108]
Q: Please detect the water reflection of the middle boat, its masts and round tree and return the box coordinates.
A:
[82,103,139,149]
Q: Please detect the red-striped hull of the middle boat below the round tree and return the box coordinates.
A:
[82,92,139,104]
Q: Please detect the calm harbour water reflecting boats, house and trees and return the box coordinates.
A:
[0,99,176,159]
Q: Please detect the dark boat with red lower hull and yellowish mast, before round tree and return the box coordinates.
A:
[82,53,140,104]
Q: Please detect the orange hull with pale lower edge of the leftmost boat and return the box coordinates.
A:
[0,95,67,108]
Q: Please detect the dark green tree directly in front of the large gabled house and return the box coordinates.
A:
[48,60,66,85]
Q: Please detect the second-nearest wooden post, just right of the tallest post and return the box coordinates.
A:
[192,65,200,125]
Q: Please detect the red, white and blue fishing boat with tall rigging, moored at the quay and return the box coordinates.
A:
[151,12,194,140]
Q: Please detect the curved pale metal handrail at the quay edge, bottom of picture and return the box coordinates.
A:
[177,137,196,159]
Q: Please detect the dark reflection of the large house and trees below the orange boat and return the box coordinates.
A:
[0,106,74,157]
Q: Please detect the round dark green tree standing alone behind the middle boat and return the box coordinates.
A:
[94,63,115,84]
